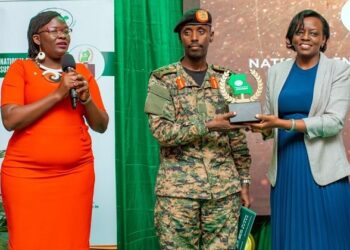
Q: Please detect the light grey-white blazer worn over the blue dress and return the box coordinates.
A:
[264,53,350,186]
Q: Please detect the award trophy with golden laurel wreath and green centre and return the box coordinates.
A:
[219,70,263,123]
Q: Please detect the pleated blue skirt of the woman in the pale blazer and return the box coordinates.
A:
[271,130,350,250]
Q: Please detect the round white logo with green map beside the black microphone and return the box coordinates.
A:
[69,44,105,79]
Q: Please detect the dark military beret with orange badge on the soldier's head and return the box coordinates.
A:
[174,8,212,32]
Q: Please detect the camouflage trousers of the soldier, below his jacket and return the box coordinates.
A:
[154,193,241,250]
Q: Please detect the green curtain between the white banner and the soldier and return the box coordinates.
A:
[115,0,183,250]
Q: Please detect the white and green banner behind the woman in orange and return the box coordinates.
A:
[0,0,117,245]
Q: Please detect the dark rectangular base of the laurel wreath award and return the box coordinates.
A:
[228,102,261,123]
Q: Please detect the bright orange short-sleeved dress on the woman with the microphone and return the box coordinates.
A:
[1,60,105,250]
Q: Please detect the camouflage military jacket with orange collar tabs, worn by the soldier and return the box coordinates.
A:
[145,62,251,249]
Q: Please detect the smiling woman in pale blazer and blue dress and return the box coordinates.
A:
[252,10,350,250]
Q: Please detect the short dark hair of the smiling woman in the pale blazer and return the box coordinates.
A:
[286,10,330,52]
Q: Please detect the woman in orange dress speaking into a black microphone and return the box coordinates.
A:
[1,11,108,250]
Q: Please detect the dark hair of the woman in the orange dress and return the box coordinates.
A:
[27,11,64,59]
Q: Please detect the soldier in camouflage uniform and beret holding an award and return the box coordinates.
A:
[145,9,251,250]
